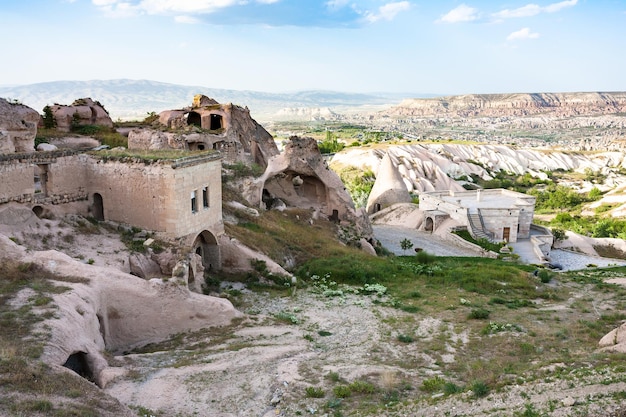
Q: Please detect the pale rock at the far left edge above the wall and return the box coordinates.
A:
[0,98,40,154]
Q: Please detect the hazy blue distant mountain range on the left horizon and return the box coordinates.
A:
[0,79,420,121]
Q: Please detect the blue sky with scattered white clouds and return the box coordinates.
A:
[0,0,626,95]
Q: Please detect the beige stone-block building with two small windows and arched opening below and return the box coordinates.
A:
[0,150,224,269]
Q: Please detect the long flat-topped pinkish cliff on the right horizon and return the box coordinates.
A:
[385,92,626,117]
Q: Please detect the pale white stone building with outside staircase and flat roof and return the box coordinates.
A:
[419,189,535,242]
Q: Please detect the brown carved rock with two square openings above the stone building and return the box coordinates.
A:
[128,95,278,168]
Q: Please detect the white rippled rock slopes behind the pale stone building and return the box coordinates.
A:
[331,144,626,193]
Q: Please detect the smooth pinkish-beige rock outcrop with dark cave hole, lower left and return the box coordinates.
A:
[0,235,242,387]
